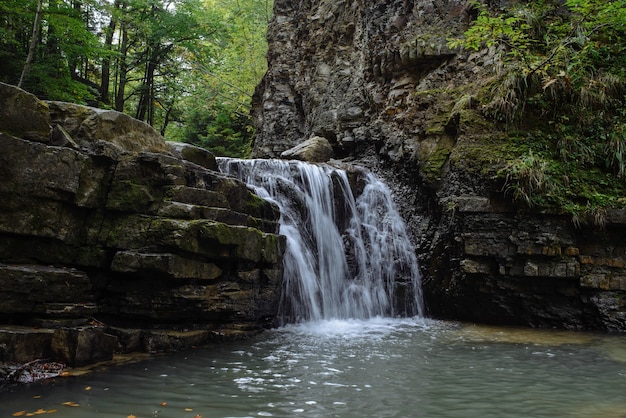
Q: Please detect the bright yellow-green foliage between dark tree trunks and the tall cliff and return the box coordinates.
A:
[167,0,272,157]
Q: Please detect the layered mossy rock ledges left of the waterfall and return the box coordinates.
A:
[0,84,284,364]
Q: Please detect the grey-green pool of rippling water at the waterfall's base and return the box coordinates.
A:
[0,319,626,418]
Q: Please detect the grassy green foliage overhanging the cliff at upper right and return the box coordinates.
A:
[449,0,626,224]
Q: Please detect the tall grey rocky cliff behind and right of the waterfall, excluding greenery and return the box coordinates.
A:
[254,0,626,331]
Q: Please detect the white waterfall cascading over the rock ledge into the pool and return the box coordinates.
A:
[218,158,423,323]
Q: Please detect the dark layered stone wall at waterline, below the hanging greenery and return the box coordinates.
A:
[425,196,626,331]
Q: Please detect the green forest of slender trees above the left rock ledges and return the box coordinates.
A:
[0,0,273,156]
